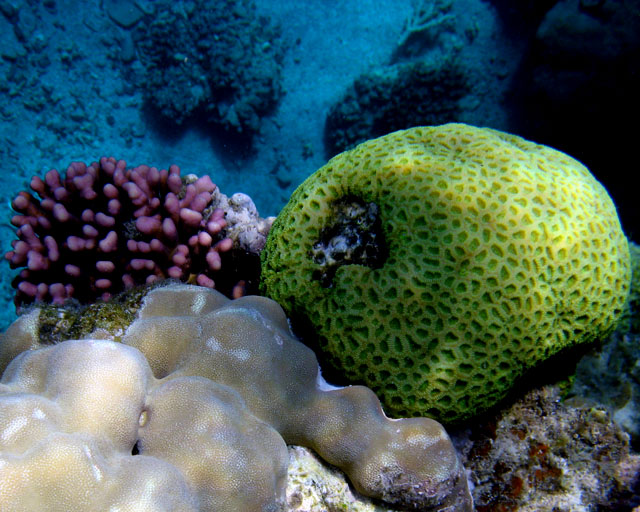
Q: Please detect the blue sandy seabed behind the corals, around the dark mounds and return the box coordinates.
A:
[0,0,638,327]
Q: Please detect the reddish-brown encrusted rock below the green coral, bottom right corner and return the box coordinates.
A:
[454,386,640,512]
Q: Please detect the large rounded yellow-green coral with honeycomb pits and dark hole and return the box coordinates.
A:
[261,124,630,421]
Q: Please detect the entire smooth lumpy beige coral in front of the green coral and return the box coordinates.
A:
[0,284,473,512]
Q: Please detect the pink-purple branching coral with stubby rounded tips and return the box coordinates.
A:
[5,157,245,308]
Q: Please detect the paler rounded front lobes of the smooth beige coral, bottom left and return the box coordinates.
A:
[0,340,287,511]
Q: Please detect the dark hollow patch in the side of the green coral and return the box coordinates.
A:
[310,196,388,288]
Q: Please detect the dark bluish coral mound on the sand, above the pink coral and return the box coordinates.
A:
[134,0,284,139]
